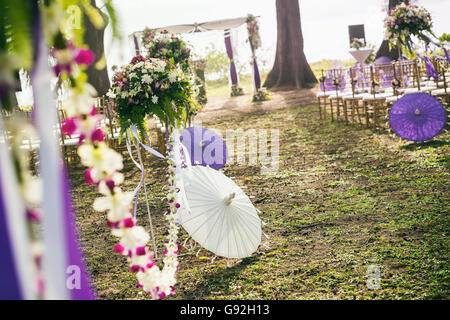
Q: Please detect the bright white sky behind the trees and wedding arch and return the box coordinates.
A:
[105,0,450,74]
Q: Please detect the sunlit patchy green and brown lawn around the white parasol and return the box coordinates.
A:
[70,87,450,299]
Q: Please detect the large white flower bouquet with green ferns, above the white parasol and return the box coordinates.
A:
[107,55,197,138]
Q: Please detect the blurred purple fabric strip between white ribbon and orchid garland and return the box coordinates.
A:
[61,167,95,300]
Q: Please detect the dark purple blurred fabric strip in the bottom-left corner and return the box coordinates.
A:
[0,172,23,300]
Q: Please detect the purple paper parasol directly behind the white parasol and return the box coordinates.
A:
[180,127,227,170]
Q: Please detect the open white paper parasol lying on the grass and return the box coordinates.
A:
[180,166,262,258]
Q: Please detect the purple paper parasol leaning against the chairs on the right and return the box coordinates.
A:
[389,93,447,142]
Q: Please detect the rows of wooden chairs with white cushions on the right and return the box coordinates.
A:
[317,59,450,127]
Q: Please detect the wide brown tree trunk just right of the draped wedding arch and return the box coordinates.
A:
[264,0,317,89]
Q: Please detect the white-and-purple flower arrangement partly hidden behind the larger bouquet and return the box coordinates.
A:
[142,28,191,73]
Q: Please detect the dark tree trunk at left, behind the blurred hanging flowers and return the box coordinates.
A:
[83,0,110,96]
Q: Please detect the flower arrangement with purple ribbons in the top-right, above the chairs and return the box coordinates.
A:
[384,2,433,51]
